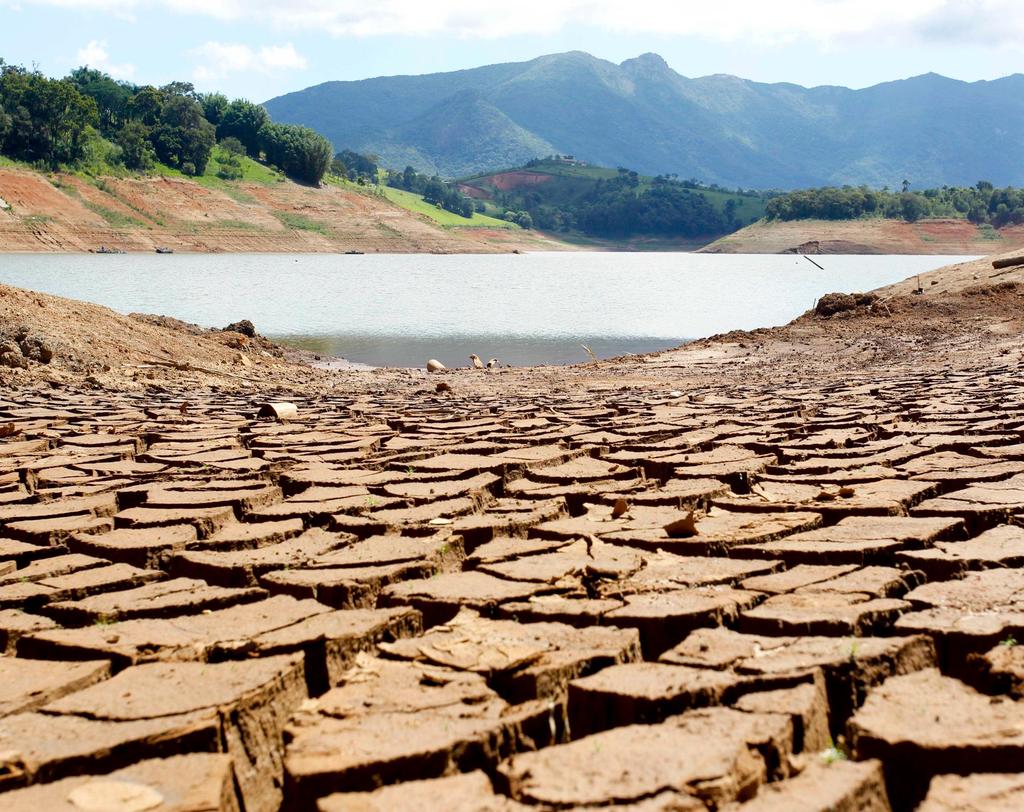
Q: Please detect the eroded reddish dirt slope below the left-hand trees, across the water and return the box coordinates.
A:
[0,169,563,253]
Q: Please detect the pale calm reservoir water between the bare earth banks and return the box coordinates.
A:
[0,253,966,366]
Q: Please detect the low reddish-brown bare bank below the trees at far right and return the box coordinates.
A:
[701,220,1024,255]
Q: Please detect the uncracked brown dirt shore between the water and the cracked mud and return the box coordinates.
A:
[0,249,1007,391]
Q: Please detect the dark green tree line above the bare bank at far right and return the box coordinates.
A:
[765,180,1024,228]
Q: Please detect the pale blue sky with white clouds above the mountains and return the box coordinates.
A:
[0,0,1024,101]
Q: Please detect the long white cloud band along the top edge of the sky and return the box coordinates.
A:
[16,0,1024,45]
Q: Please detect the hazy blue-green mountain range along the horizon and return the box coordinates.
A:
[265,51,1024,189]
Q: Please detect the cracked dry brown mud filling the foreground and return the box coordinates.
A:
[6,276,1024,812]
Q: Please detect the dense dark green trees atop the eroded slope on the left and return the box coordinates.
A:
[0,59,333,183]
